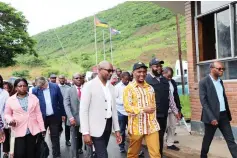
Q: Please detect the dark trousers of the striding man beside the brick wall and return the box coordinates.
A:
[201,112,237,158]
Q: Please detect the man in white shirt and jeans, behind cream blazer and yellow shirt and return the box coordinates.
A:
[115,72,131,153]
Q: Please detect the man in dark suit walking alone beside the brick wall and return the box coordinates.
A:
[199,61,237,158]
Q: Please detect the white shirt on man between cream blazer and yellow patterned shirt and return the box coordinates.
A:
[115,81,128,116]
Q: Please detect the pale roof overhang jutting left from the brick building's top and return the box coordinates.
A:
[152,1,185,15]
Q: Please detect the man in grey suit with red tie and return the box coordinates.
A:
[64,73,85,158]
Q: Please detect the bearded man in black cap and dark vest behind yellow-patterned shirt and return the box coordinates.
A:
[146,58,178,156]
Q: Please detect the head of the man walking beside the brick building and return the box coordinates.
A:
[210,61,225,77]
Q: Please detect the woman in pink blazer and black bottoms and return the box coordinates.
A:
[5,78,45,158]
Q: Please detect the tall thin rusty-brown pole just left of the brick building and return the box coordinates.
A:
[176,14,185,95]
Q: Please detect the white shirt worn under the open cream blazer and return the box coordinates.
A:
[99,79,112,118]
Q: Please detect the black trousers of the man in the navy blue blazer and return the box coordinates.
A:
[44,115,62,157]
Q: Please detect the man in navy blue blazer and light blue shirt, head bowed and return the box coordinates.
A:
[32,77,66,158]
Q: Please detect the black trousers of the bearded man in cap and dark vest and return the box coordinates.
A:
[157,117,167,156]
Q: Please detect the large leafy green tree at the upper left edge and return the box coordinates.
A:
[0,2,37,67]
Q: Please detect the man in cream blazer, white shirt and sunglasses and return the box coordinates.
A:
[80,61,122,158]
